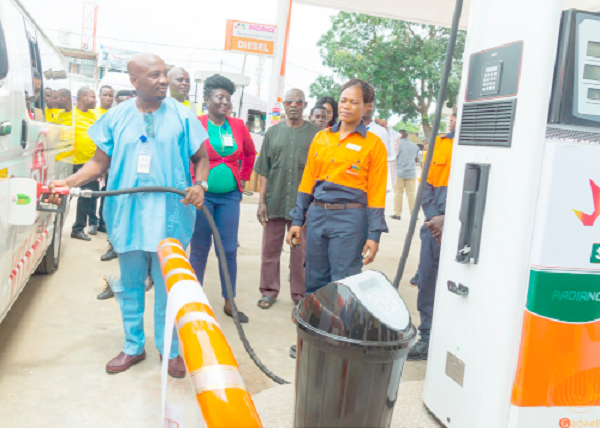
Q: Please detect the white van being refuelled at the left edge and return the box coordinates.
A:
[0,0,74,321]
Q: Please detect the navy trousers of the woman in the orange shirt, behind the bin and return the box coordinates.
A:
[305,204,368,293]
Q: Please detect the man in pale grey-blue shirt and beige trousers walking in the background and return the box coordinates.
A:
[391,130,419,220]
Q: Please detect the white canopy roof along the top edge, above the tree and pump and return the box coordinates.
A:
[294,0,600,30]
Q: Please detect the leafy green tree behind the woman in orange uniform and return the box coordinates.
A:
[310,12,465,137]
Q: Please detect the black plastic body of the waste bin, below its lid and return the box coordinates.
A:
[294,328,408,428]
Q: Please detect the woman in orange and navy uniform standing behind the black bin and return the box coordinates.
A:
[287,79,388,293]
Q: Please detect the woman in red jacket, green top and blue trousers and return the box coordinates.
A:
[190,74,256,322]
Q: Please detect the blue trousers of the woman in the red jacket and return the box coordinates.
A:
[190,190,242,299]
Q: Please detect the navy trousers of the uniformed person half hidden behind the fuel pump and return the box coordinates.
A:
[417,225,441,342]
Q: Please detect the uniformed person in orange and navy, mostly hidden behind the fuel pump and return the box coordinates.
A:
[407,112,456,361]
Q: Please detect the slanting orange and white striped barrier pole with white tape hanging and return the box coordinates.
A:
[157,238,262,428]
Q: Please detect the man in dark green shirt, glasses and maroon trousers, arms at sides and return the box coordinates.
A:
[254,89,321,309]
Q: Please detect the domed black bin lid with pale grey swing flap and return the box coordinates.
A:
[295,270,415,346]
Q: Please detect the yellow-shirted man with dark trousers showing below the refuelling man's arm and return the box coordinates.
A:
[71,87,100,241]
